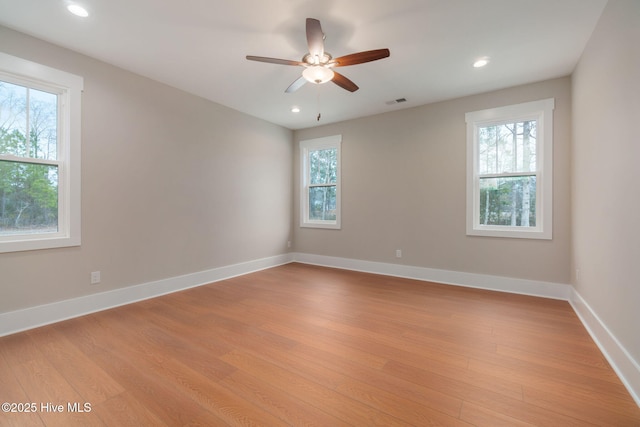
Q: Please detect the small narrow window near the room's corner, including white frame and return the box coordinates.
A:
[300,135,342,228]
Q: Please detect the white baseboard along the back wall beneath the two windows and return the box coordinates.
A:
[293,253,572,301]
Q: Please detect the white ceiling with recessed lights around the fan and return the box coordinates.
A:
[0,0,607,129]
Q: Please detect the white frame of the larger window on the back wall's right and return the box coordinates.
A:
[465,98,555,239]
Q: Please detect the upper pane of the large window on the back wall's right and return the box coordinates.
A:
[478,120,537,174]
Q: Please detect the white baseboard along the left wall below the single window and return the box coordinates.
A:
[0,254,292,337]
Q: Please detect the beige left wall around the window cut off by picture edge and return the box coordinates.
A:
[0,27,292,313]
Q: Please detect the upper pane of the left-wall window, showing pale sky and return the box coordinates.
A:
[0,81,58,160]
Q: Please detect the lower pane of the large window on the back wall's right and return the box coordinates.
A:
[479,176,536,227]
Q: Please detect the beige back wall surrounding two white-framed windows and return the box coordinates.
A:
[294,77,571,283]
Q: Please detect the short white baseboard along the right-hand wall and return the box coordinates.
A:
[569,288,640,406]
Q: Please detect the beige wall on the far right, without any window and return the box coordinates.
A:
[572,0,640,362]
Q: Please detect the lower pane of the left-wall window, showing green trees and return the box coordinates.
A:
[0,161,58,235]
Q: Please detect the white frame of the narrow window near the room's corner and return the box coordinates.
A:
[300,135,342,229]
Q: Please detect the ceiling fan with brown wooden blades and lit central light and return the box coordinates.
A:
[247,18,390,93]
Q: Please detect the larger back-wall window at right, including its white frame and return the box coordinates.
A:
[466,99,554,239]
